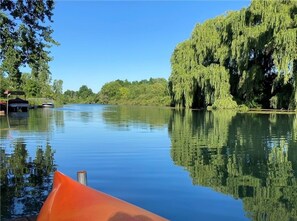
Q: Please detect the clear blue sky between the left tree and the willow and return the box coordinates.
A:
[50,0,250,93]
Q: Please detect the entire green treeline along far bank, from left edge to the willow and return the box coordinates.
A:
[0,74,170,106]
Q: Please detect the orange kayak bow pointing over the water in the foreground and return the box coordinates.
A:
[37,171,167,221]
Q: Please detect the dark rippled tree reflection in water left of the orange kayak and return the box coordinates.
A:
[0,139,55,218]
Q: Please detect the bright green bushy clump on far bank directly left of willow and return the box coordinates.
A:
[98,78,170,106]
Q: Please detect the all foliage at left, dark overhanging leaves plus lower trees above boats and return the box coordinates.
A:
[0,0,63,105]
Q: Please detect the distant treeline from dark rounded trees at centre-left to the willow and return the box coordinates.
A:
[63,78,170,106]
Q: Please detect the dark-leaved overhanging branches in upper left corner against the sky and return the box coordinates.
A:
[0,0,58,89]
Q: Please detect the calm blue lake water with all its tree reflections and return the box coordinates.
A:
[0,105,297,221]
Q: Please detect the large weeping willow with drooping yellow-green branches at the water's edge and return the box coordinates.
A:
[169,0,297,109]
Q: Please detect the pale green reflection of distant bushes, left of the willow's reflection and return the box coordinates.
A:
[102,106,171,128]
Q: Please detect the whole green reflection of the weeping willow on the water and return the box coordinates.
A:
[169,111,297,220]
